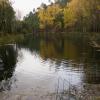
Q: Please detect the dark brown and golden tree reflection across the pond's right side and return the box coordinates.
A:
[17,37,100,83]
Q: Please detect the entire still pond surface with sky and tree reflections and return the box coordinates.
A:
[0,37,100,100]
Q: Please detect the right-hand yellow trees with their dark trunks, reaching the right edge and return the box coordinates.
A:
[64,0,100,32]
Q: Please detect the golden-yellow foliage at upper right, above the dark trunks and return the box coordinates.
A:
[64,0,100,27]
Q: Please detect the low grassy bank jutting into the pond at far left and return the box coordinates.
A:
[0,34,24,45]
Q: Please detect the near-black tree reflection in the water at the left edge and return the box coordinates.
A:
[0,45,17,91]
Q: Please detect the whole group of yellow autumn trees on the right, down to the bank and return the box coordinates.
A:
[35,0,100,32]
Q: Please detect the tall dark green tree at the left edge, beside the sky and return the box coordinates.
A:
[0,0,15,33]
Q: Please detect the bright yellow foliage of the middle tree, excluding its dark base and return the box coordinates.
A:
[38,4,62,28]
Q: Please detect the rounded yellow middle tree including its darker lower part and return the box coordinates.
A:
[38,4,63,31]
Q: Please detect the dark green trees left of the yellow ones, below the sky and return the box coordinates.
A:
[0,0,39,35]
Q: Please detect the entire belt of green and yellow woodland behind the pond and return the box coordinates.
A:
[0,0,100,34]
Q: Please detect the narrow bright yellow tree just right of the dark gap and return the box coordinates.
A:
[64,0,79,28]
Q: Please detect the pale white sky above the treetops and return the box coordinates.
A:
[11,0,54,18]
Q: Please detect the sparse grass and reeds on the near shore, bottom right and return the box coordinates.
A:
[55,78,100,100]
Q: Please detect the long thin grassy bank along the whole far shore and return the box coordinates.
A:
[0,32,100,45]
